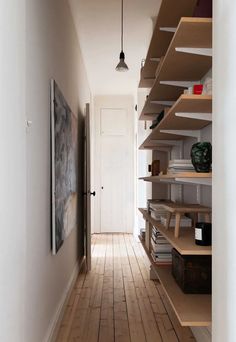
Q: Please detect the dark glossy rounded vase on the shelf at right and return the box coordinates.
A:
[191,142,212,172]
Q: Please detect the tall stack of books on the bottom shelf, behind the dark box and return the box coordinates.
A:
[151,227,172,265]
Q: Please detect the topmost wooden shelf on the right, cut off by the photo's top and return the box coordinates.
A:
[139,0,197,88]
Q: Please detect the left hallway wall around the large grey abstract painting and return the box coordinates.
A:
[24,0,90,342]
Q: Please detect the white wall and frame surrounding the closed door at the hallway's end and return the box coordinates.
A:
[92,95,136,233]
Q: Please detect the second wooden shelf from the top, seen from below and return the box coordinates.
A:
[140,18,212,120]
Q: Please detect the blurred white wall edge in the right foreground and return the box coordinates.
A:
[212,0,236,342]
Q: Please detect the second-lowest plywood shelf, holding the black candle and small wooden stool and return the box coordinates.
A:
[139,208,212,255]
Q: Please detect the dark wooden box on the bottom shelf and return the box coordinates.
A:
[172,249,211,294]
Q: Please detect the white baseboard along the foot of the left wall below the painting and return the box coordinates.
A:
[43,257,85,342]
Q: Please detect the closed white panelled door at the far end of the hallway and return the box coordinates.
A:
[100,109,130,232]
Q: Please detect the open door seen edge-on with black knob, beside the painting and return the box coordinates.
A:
[84,103,91,271]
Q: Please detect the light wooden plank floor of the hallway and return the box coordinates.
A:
[56,234,195,342]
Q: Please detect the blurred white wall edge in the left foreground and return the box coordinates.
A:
[0,0,26,342]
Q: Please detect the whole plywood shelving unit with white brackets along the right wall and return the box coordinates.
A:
[139,1,212,327]
